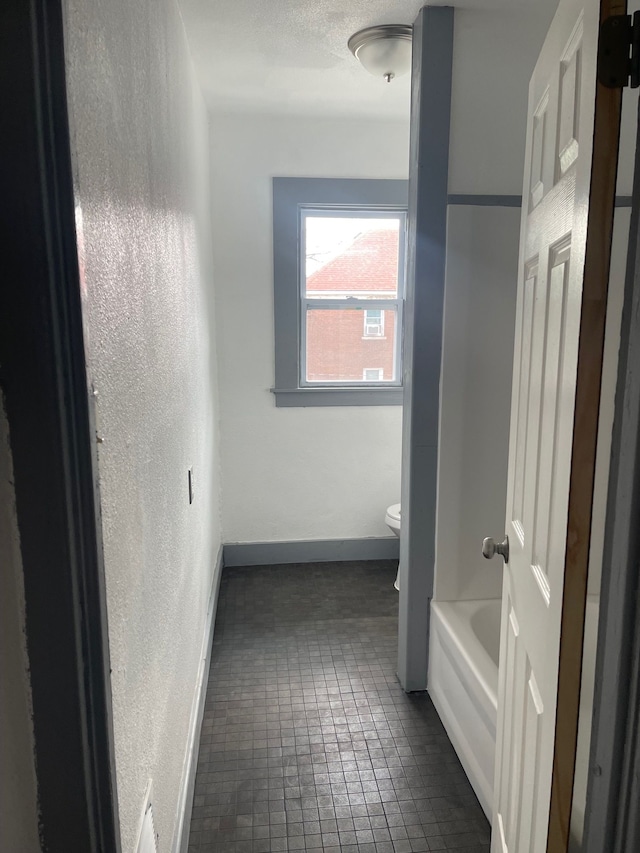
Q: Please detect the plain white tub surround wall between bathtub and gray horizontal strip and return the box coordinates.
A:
[434,206,520,601]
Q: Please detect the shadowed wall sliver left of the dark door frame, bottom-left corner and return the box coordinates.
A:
[0,391,40,853]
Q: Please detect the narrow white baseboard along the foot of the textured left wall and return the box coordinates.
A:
[172,545,224,853]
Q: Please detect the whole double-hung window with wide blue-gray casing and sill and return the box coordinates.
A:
[273,178,407,406]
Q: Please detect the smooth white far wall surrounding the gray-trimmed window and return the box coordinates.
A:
[212,115,409,542]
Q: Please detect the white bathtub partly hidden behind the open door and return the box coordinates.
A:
[428,599,501,820]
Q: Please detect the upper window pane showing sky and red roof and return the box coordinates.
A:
[303,214,400,299]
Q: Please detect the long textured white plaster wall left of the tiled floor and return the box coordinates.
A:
[66,0,220,853]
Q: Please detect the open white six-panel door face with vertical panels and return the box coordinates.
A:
[492,0,615,853]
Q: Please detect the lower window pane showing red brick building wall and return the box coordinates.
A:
[305,308,397,384]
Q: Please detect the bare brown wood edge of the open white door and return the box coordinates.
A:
[547,0,626,853]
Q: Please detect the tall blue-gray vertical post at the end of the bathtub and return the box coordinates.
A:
[398,6,454,691]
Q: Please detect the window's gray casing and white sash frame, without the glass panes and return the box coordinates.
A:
[271,178,408,407]
